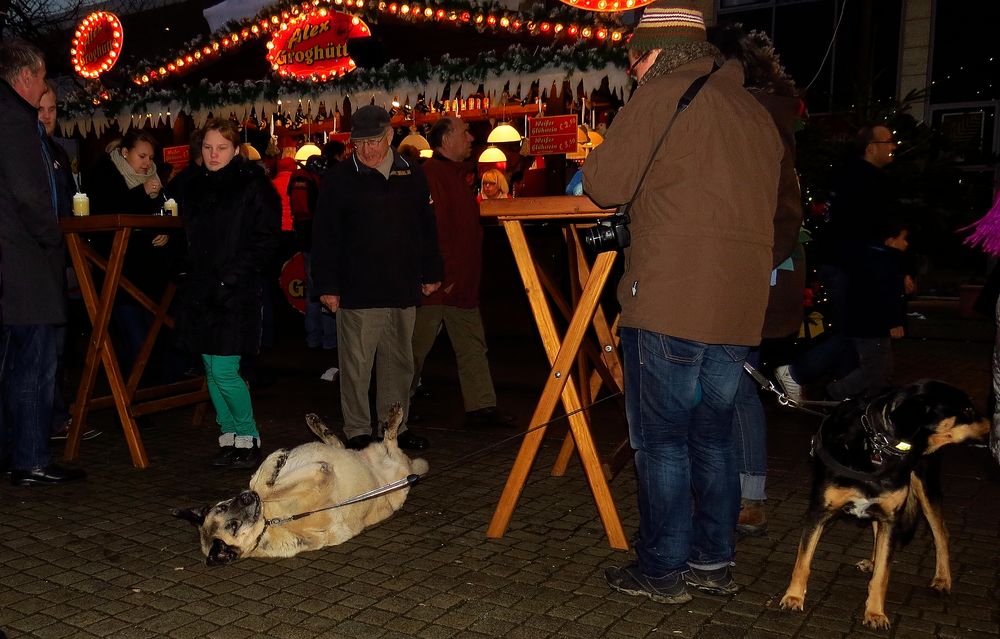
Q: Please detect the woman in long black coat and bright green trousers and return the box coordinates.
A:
[175,119,281,468]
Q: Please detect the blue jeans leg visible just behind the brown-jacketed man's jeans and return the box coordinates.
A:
[733,348,767,500]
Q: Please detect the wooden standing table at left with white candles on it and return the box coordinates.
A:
[60,215,208,468]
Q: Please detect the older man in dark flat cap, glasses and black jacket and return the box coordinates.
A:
[312,105,443,450]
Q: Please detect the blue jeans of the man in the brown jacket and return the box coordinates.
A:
[621,328,749,578]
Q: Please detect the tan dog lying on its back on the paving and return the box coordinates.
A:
[173,404,428,566]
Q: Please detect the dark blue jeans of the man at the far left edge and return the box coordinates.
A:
[0,324,56,470]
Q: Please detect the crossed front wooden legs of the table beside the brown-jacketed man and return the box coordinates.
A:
[486,220,628,550]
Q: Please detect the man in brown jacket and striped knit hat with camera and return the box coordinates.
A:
[583,0,782,603]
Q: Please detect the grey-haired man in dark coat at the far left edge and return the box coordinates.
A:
[0,41,85,486]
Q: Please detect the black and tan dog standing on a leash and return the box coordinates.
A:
[781,380,990,629]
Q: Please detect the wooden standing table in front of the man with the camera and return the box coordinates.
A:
[480,196,628,550]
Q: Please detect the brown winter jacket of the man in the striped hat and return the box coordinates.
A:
[583,58,782,346]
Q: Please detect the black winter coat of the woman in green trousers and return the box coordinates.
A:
[175,156,281,355]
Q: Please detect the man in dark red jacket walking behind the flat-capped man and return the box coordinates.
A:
[410,117,513,427]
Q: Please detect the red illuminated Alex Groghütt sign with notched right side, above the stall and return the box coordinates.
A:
[267,9,371,80]
